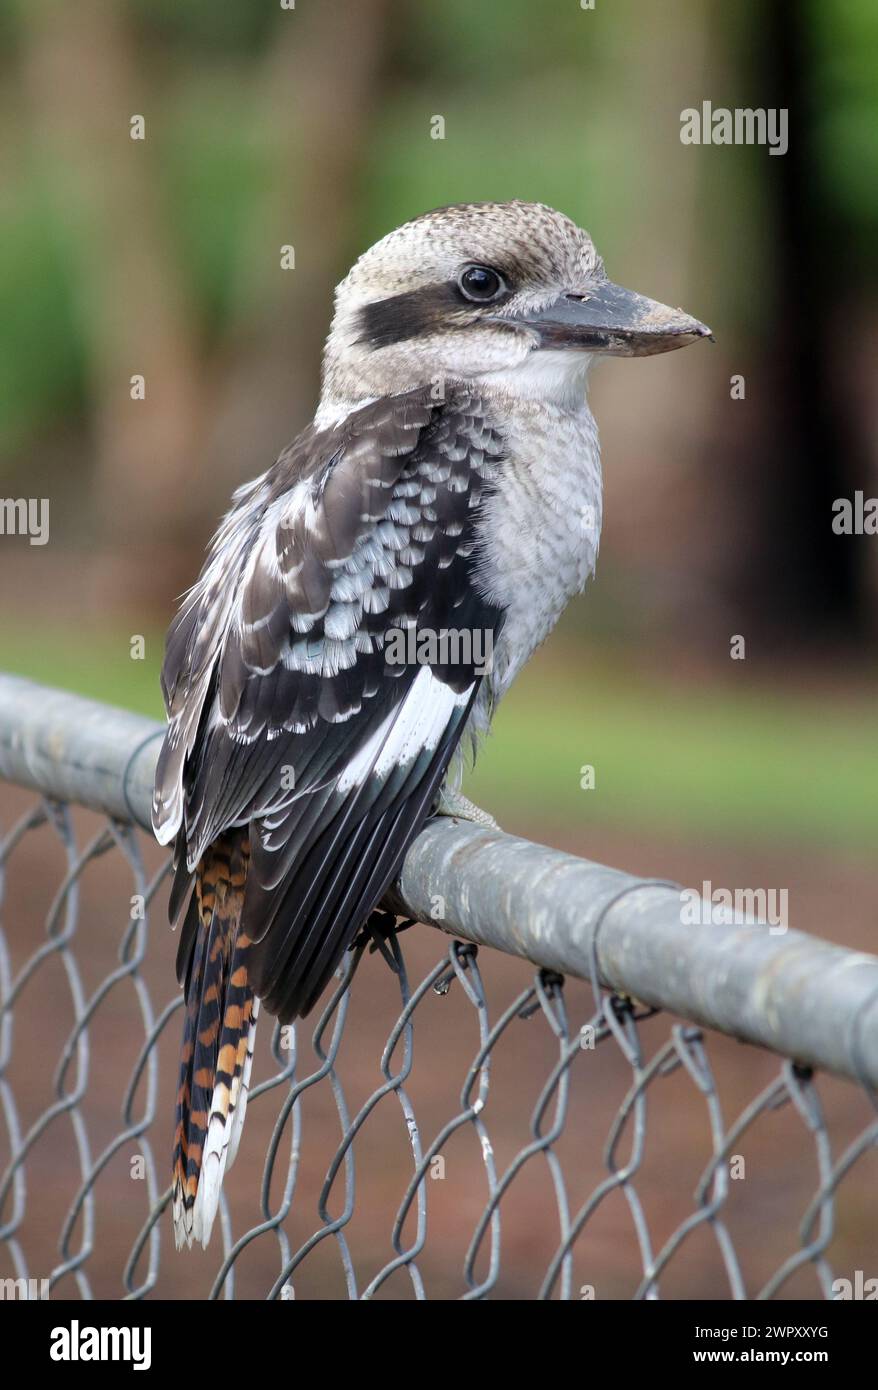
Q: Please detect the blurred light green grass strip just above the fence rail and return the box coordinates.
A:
[4,630,878,849]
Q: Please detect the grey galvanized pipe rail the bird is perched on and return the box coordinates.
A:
[0,676,878,1087]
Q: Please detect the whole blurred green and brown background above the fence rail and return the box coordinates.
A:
[0,0,878,1287]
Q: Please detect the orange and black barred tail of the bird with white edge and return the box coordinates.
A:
[172,831,258,1250]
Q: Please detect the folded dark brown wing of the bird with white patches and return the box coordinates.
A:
[153,389,503,1019]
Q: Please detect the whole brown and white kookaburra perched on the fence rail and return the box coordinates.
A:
[153,200,711,1248]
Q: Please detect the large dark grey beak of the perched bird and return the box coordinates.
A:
[504,279,713,357]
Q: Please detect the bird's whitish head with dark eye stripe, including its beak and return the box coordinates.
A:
[324,202,710,406]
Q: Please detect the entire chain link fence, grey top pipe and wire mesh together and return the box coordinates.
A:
[0,677,878,1300]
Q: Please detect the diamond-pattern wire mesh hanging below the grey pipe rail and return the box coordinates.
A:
[0,794,878,1300]
